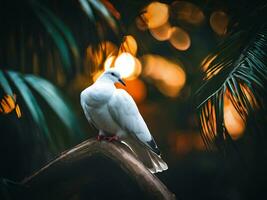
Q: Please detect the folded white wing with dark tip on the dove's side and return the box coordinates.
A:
[108,89,160,155]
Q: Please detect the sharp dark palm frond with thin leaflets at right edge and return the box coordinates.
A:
[197,25,267,148]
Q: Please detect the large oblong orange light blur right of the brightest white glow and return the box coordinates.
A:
[143,55,186,97]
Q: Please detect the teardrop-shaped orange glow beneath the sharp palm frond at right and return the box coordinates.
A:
[224,95,245,139]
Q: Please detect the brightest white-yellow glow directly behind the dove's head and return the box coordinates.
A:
[104,53,142,80]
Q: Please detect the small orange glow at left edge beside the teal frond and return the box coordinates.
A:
[0,95,21,118]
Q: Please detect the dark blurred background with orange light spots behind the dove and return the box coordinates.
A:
[0,0,267,199]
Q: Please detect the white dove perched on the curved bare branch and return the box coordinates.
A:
[80,68,168,173]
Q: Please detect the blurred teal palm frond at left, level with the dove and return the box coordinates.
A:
[0,70,82,148]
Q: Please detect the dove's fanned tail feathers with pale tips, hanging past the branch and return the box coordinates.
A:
[121,138,168,173]
